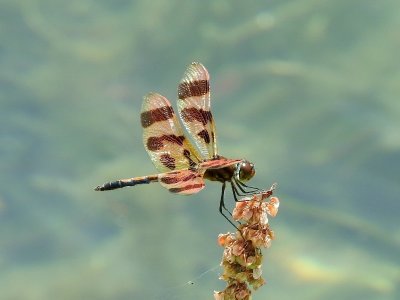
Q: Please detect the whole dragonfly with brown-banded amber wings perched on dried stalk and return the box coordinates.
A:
[95,62,260,227]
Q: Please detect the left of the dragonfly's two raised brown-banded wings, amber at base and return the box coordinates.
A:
[140,93,200,172]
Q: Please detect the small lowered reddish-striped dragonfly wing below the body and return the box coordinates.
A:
[158,170,205,195]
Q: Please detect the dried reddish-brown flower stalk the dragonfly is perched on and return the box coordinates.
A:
[214,185,279,300]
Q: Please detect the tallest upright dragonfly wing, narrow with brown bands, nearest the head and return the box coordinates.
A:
[178,62,217,159]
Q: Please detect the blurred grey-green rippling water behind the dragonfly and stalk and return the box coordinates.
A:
[0,0,400,300]
